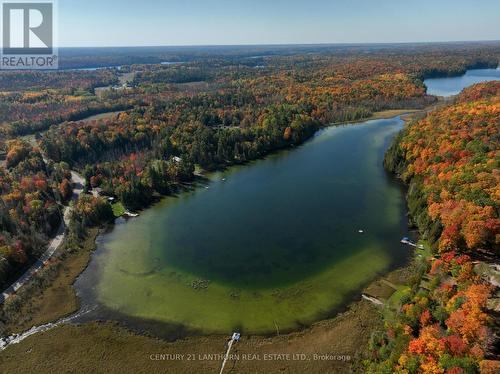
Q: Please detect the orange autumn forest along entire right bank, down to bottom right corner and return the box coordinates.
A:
[369,81,500,373]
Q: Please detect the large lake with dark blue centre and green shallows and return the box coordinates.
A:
[76,117,411,333]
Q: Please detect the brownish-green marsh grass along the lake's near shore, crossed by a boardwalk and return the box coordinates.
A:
[0,255,417,373]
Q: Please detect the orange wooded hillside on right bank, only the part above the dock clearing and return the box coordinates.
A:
[388,82,500,251]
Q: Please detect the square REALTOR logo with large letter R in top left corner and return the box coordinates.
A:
[0,0,57,69]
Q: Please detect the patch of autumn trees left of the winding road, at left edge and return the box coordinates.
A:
[0,140,72,285]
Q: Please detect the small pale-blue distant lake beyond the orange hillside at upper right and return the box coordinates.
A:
[424,68,500,96]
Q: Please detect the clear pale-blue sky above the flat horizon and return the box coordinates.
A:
[58,0,500,47]
